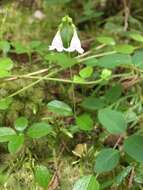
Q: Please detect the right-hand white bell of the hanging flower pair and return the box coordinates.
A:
[65,29,84,54]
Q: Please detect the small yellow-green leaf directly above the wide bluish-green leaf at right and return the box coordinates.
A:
[115,44,135,54]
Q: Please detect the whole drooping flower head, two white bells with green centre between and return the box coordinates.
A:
[49,16,84,54]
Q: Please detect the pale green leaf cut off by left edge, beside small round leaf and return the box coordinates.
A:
[0,127,16,142]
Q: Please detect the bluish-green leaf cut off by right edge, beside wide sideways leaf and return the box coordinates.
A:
[132,50,143,69]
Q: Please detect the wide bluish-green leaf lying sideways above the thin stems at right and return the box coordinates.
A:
[98,53,132,69]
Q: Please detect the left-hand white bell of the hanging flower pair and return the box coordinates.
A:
[49,30,65,52]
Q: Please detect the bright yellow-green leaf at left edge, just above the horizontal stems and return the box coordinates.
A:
[0,58,13,71]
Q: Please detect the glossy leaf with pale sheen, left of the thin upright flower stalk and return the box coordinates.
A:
[47,100,73,116]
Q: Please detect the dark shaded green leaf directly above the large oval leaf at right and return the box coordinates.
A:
[105,84,122,103]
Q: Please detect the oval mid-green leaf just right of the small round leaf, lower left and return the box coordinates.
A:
[27,122,52,138]
